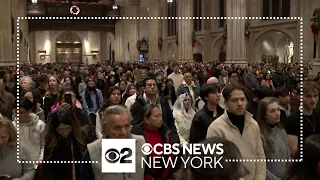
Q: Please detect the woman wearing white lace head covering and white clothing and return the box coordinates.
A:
[172,93,196,144]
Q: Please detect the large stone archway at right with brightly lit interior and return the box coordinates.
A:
[250,30,294,63]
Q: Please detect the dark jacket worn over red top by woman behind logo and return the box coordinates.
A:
[131,123,172,179]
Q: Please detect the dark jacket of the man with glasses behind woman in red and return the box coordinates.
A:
[131,93,180,143]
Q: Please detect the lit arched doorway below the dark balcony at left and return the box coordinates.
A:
[56,32,82,63]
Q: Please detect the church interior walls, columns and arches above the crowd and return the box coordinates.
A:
[0,0,320,66]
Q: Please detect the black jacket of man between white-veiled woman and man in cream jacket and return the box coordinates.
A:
[189,105,224,143]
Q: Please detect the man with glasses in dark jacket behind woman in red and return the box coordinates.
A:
[131,77,180,143]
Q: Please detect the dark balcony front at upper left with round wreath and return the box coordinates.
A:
[27,0,121,17]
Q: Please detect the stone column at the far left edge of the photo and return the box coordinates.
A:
[0,0,13,66]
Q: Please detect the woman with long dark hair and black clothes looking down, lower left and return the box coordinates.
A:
[43,108,86,180]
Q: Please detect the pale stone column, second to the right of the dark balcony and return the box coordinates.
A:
[148,0,161,61]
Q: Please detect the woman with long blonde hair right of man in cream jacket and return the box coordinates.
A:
[257,97,291,180]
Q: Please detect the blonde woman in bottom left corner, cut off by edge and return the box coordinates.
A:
[0,118,35,180]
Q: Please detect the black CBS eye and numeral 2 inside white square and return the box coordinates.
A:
[104,148,132,164]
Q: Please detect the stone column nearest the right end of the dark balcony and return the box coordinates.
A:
[128,0,141,61]
